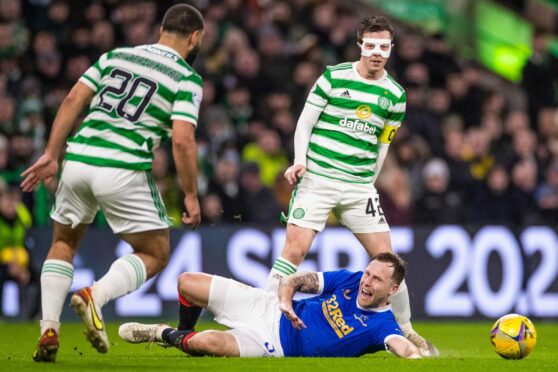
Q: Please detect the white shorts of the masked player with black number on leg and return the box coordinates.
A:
[288,172,389,233]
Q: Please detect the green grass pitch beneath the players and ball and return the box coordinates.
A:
[0,321,558,372]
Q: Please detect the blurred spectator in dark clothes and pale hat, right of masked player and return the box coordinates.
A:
[414,158,465,225]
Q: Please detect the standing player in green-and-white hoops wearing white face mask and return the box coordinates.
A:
[266,17,438,355]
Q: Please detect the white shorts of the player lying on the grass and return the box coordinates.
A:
[207,275,283,357]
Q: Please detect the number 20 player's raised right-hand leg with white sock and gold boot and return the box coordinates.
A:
[71,229,169,353]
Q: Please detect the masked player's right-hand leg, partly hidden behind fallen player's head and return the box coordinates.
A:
[354,231,439,356]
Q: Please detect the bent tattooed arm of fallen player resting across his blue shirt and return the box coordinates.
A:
[277,272,320,329]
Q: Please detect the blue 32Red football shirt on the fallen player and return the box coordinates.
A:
[279,270,403,357]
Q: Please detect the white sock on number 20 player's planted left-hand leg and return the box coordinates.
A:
[41,259,74,334]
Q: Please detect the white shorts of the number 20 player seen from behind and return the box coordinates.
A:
[50,160,171,234]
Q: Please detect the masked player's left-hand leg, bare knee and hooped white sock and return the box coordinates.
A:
[264,223,318,292]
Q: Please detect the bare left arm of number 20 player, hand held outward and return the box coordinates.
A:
[21,81,95,192]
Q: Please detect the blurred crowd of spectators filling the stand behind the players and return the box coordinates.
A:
[0,0,558,230]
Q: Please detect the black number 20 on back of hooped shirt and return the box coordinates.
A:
[98,68,157,122]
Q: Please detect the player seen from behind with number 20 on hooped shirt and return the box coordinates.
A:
[22,5,204,362]
